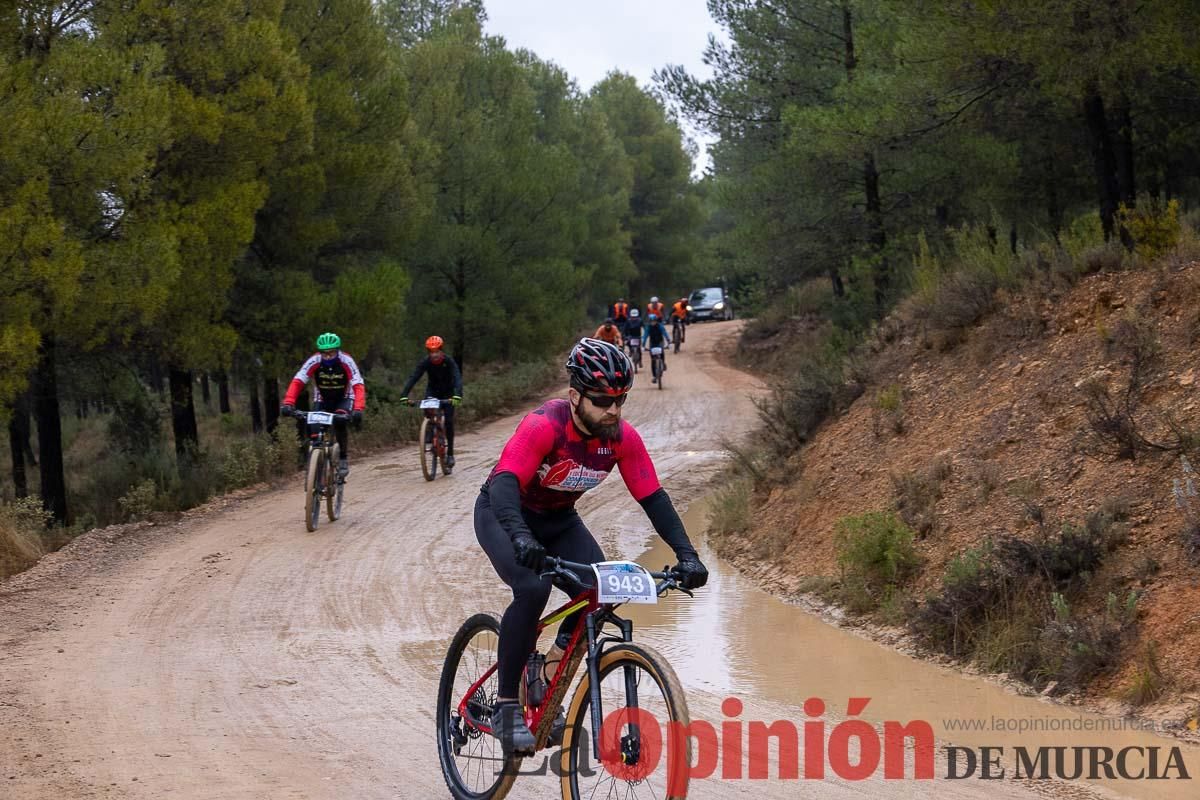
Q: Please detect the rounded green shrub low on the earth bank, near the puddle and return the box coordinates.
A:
[834,512,920,610]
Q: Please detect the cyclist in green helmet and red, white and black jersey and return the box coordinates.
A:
[280,333,367,477]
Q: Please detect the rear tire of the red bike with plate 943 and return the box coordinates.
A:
[436,614,522,800]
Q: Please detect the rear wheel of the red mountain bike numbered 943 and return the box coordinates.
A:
[437,614,521,800]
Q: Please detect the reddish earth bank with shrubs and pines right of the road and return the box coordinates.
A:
[676,0,1200,702]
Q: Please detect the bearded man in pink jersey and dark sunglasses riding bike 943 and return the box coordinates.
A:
[475,338,708,752]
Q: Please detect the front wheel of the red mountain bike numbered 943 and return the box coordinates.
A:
[559,643,691,800]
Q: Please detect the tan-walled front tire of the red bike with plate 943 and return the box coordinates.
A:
[559,642,691,800]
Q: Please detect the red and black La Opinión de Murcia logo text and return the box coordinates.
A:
[494,697,1192,796]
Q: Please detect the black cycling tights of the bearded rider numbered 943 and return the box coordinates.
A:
[475,491,604,697]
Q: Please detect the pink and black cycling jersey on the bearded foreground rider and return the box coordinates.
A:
[485,399,661,513]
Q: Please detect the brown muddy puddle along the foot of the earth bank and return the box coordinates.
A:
[604,503,1200,800]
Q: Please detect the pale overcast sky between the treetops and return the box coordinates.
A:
[484,0,719,172]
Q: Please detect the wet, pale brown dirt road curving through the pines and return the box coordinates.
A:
[0,323,1171,800]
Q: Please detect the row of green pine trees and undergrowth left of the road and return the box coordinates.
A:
[0,0,716,576]
